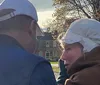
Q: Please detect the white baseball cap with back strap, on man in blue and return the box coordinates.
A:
[0,0,42,36]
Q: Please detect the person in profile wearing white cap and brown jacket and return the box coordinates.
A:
[57,19,100,85]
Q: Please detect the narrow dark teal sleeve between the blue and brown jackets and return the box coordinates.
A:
[57,59,69,85]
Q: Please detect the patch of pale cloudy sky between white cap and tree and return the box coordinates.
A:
[30,0,54,28]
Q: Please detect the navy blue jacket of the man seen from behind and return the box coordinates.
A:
[0,35,56,85]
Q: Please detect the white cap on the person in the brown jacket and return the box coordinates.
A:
[61,19,100,52]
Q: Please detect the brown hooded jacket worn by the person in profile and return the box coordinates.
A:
[65,46,100,85]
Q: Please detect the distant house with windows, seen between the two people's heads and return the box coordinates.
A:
[37,32,61,61]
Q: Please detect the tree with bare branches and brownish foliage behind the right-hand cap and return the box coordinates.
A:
[43,0,100,33]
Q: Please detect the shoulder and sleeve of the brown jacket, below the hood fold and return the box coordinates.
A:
[65,66,100,85]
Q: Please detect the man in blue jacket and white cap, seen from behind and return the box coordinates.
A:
[0,0,56,85]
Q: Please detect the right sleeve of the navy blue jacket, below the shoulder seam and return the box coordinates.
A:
[29,62,56,85]
